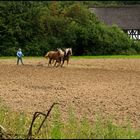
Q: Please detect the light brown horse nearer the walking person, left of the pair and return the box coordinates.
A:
[45,49,64,67]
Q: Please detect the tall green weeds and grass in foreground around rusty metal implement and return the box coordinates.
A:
[0,105,140,139]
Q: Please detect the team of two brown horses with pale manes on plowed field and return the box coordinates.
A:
[45,48,72,67]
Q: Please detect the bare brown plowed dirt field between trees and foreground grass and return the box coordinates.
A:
[0,58,140,127]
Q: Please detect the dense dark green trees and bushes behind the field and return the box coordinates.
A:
[0,1,140,56]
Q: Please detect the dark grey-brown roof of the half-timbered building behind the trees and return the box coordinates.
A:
[89,5,140,29]
